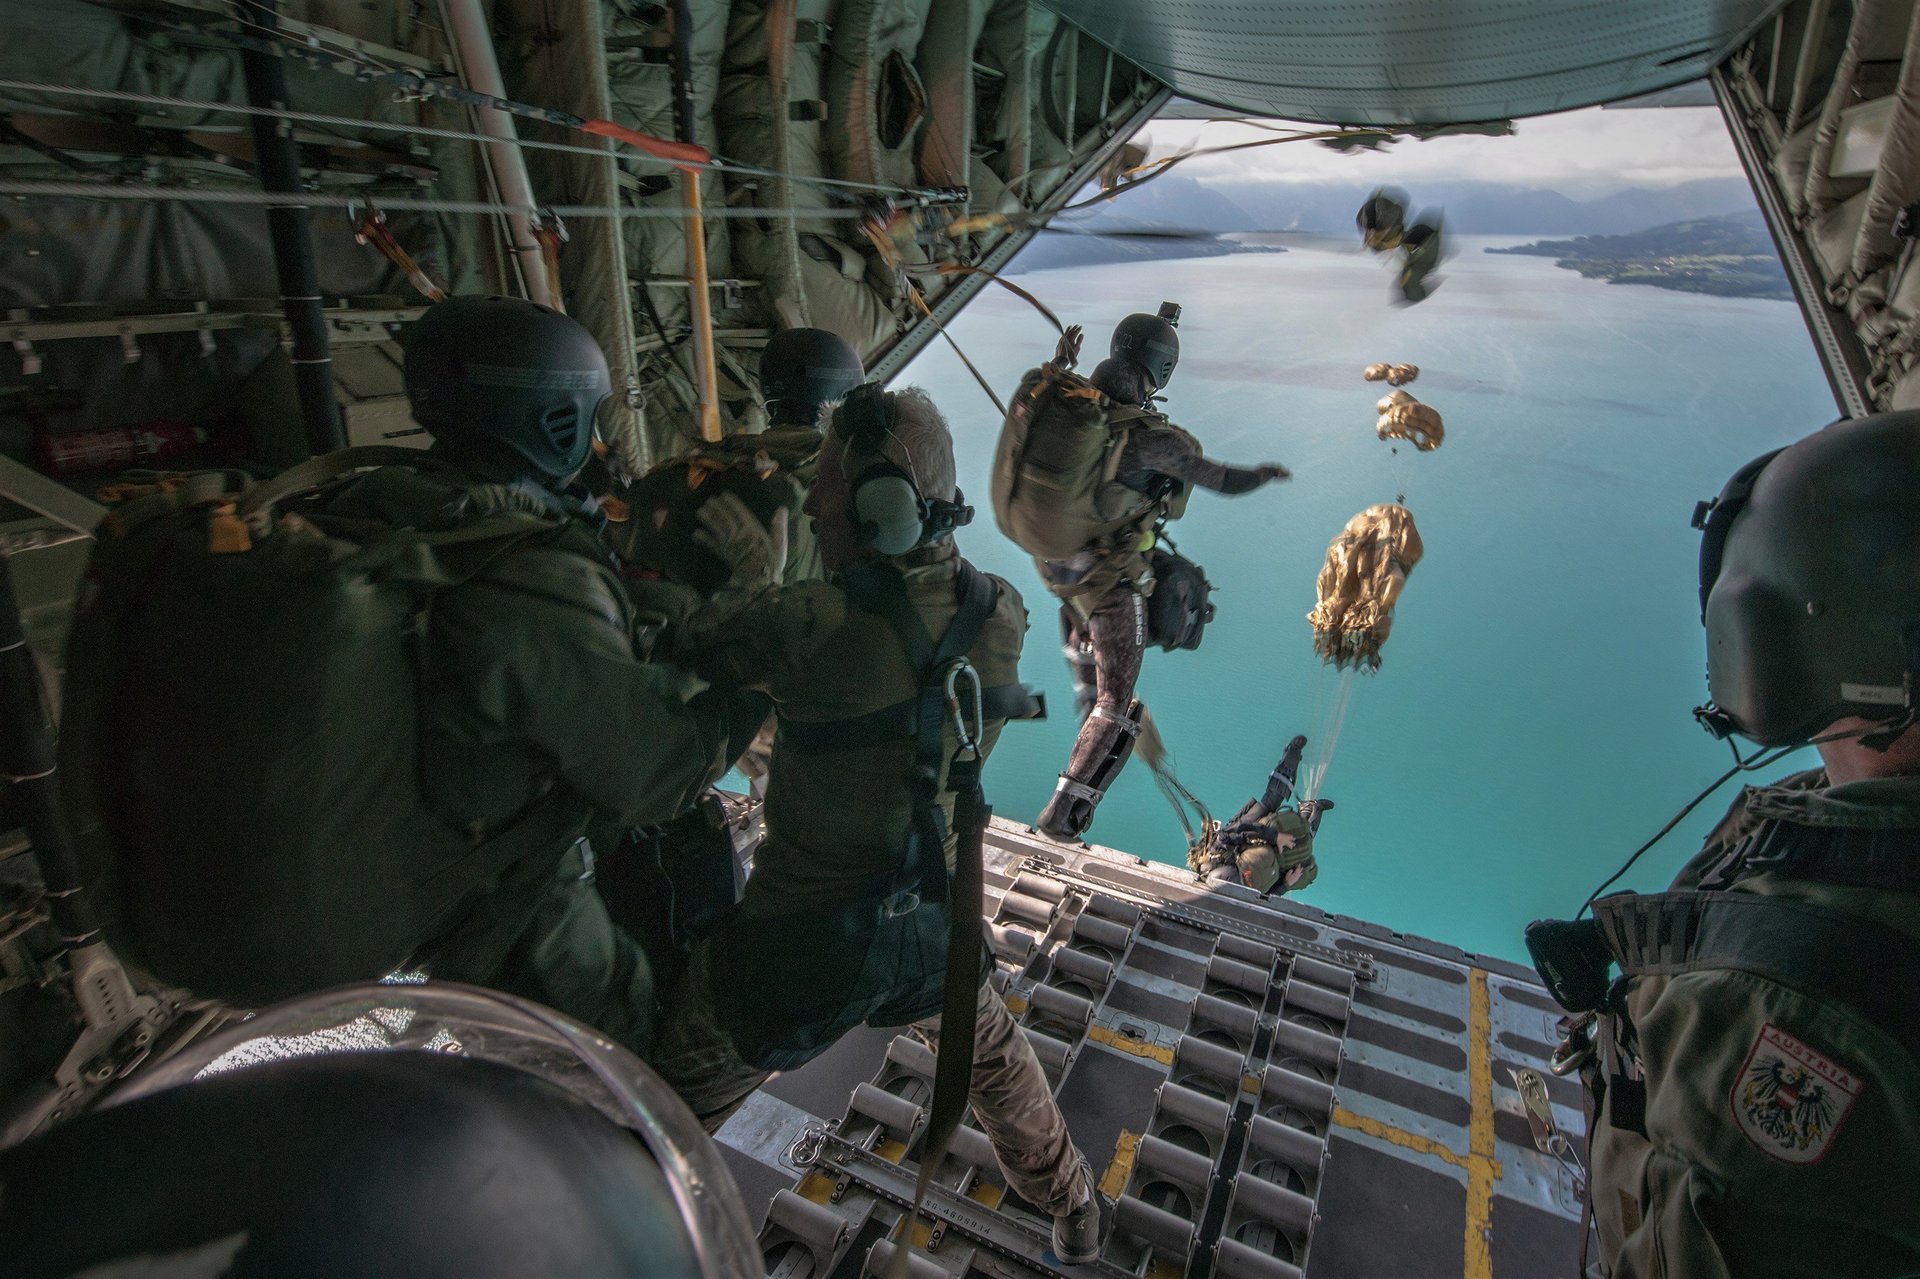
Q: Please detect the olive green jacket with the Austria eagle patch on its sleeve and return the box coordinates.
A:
[1592,772,1920,1279]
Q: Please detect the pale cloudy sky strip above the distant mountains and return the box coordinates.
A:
[1148,108,1740,196]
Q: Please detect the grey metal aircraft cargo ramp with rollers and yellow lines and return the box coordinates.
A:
[720,820,1586,1279]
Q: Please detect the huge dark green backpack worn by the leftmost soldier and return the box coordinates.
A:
[61,447,605,1006]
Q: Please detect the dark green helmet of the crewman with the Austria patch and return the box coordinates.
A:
[1693,411,1920,745]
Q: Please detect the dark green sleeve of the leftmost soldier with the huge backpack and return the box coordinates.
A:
[432,547,726,824]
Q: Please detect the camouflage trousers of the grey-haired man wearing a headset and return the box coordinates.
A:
[649,945,1092,1216]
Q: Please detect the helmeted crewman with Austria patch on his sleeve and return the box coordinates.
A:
[1528,413,1920,1279]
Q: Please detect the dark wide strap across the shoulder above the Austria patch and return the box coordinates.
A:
[1594,893,1920,1060]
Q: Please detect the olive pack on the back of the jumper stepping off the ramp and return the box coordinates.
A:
[993,365,1165,559]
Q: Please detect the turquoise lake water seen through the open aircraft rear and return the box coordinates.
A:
[895,238,1836,960]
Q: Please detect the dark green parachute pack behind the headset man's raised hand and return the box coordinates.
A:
[607,426,822,595]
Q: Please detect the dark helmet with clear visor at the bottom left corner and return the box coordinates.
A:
[0,983,760,1279]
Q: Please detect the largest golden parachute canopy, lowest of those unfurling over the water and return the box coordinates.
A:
[1308,503,1427,670]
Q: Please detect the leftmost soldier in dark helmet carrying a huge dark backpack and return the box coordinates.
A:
[67,298,778,1050]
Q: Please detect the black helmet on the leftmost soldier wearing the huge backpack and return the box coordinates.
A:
[405,296,612,480]
